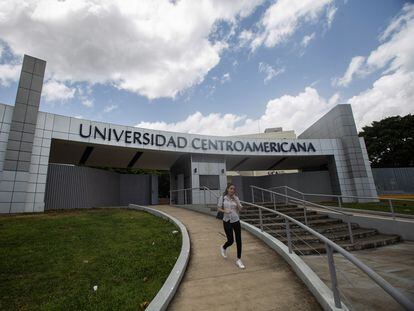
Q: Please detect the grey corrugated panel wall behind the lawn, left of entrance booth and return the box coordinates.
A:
[45,164,158,210]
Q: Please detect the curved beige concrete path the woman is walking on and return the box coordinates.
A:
[151,205,321,311]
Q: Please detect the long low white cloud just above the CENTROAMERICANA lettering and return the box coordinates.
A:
[136,87,337,136]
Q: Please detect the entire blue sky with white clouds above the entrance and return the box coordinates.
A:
[0,0,414,135]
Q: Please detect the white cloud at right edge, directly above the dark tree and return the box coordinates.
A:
[347,4,414,128]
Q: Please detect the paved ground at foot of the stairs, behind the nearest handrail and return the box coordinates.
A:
[302,242,414,311]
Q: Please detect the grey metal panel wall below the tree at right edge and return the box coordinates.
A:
[372,167,414,194]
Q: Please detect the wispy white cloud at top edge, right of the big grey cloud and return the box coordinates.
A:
[244,0,335,51]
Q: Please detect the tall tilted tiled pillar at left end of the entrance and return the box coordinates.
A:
[0,55,46,213]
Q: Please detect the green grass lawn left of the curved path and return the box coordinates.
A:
[0,209,181,310]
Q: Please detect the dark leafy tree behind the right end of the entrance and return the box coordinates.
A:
[359,114,414,167]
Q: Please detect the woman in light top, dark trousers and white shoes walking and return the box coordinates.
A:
[217,184,245,269]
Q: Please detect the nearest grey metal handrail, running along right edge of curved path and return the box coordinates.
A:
[240,201,414,310]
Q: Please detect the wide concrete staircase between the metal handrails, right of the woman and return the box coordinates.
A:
[240,203,400,255]
